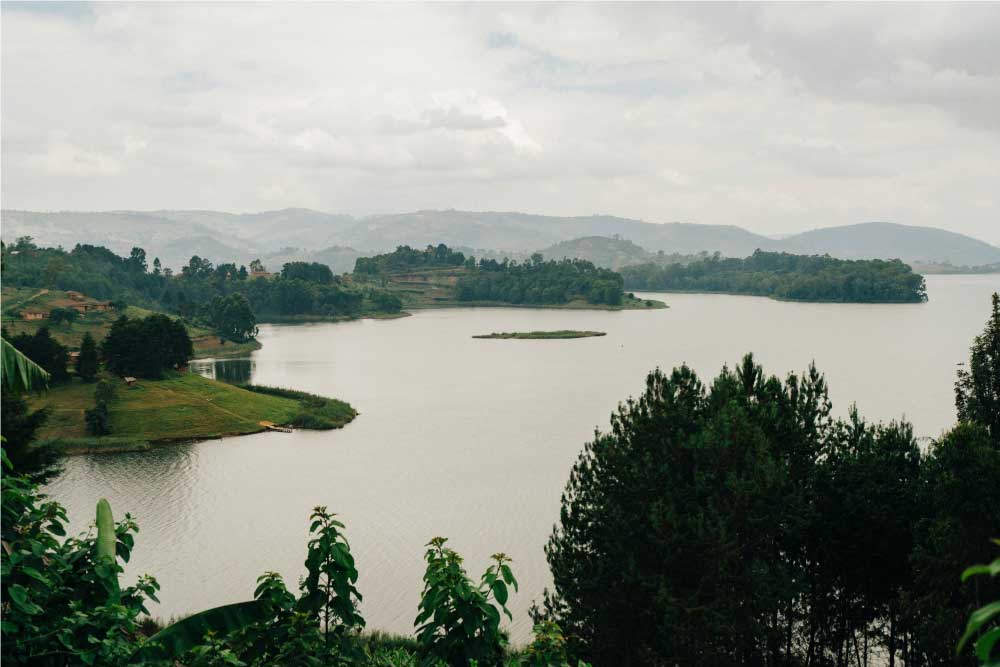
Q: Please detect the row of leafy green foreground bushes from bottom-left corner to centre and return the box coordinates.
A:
[0,453,562,667]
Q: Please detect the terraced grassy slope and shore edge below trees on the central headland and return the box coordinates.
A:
[356,268,666,310]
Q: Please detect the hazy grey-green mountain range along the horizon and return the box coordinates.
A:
[2,209,1000,272]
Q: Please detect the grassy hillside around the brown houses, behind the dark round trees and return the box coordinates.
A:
[2,287,260,359]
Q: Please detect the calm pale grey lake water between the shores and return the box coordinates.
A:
[49,275,1000,641]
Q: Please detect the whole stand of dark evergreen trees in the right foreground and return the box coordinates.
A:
[535,332,1000,667]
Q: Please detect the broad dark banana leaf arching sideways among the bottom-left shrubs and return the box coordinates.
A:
[135,600,270,660]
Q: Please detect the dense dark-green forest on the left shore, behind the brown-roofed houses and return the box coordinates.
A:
[2,238,401,341]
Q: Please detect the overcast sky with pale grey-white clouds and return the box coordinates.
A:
[2,2,1000,244]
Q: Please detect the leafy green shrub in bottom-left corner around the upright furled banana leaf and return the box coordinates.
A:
[0,453,159,667]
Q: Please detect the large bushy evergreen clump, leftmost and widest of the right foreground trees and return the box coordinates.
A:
[545,355,832,665]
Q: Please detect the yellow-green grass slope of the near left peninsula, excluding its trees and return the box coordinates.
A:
[32,374,355,442]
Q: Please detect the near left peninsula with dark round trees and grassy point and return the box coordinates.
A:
[2,313,357,463]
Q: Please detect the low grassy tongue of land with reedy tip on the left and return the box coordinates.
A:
[31,373,357,454]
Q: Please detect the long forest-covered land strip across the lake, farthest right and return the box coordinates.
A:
[621,250,927,303]
